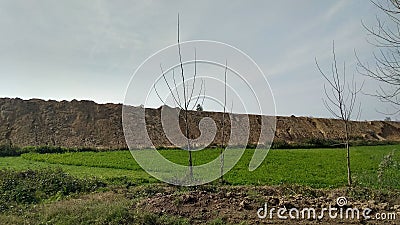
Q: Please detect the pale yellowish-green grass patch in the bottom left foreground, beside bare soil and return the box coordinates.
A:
[0,191,189,225]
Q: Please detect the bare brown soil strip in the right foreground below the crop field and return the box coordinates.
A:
[136,186,400,224]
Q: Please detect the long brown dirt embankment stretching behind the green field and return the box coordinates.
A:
[0,98,400,149]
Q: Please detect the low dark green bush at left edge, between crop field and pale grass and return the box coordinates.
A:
[0,169,106,211]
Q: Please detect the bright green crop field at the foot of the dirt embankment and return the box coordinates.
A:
[0,145,400,188]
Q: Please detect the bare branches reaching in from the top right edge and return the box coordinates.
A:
[355,0,400,112]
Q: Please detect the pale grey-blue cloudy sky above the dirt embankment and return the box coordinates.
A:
[0,0,400,120]
